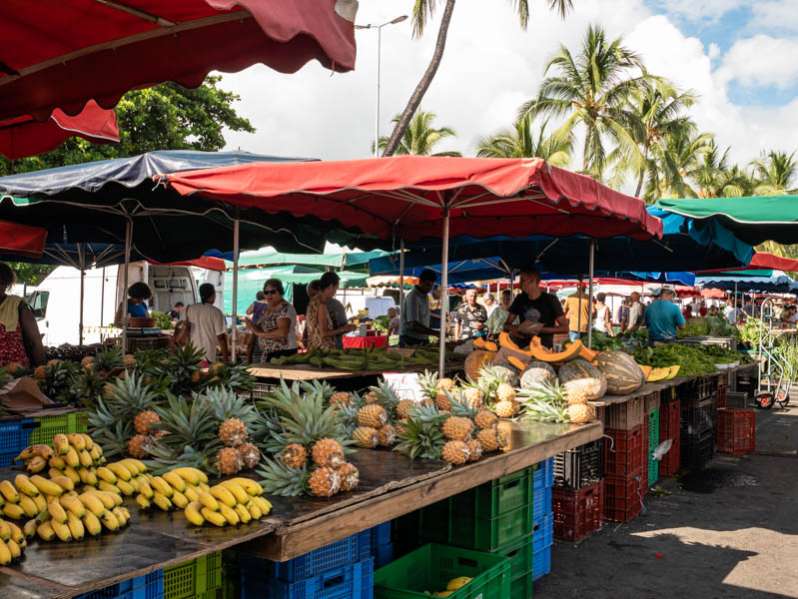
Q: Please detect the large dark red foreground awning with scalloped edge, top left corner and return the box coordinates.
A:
[0,0,357,121]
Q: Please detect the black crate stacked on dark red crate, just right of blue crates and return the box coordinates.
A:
[552,441,604,542]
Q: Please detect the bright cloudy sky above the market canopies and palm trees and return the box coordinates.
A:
[217,0,798,166]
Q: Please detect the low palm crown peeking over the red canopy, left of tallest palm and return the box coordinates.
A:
[477,116,573,167]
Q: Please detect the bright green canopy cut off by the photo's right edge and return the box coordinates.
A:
[657,196,798,245]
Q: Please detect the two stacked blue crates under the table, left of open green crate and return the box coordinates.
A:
[239,530,374,599]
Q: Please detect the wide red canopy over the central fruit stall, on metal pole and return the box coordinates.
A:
[163,156,662,241]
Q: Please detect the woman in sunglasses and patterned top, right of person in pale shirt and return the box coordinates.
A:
[246,279,297,362]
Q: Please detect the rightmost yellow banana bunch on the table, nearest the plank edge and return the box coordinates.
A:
[184,478,272,526]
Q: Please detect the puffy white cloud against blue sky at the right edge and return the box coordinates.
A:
[718,34,798,89]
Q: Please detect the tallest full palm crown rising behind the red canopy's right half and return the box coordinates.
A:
[521,26,646,179]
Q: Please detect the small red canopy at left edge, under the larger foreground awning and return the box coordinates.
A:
[0,100,119,160]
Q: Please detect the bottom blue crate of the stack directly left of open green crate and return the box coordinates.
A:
[241,558,374,599]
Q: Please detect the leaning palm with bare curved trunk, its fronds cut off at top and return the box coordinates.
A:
[383,0,573,156]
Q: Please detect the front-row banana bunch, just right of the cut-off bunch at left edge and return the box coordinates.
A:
[25,487,130,544]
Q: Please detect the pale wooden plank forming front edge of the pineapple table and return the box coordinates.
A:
[242,422,603,561]
